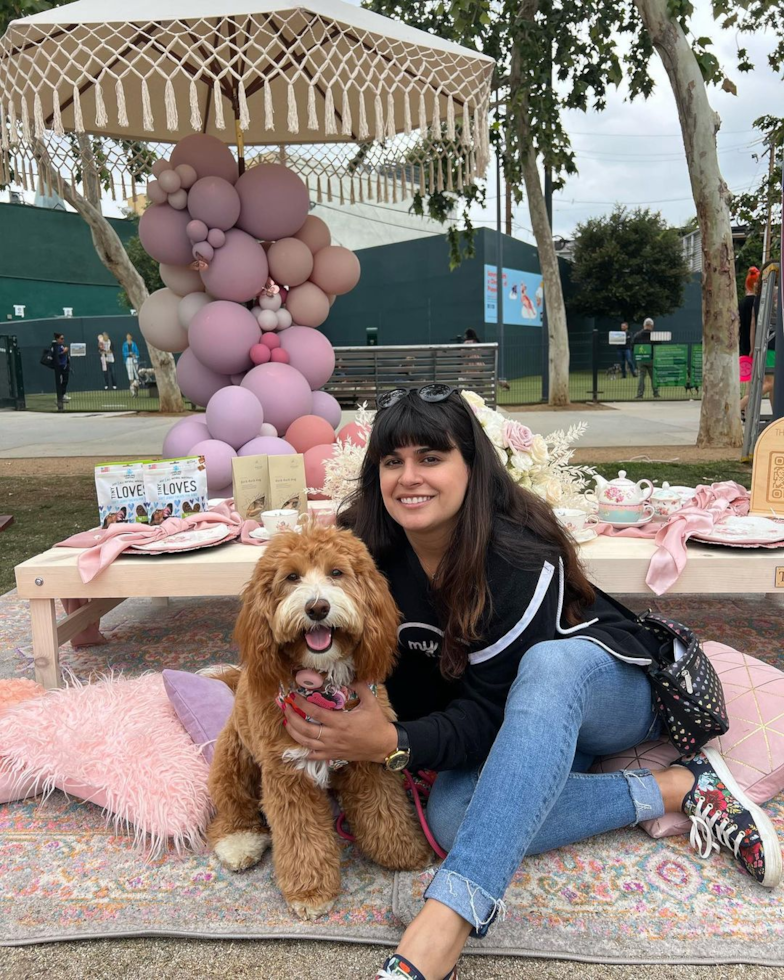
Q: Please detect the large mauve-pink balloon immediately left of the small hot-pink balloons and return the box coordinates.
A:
[188,298,261,375]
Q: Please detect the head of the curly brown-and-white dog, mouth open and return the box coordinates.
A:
[237,524,399,692]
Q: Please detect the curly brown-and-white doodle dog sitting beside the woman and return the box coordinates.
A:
[208,524,432,919]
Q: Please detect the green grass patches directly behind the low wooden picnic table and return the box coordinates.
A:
[0,460,751,594]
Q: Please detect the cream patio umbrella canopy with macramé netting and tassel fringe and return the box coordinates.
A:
[0,0,493,197]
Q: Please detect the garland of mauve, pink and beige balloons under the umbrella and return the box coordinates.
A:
[139,133,360,493]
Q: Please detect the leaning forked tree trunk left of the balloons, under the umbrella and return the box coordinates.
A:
[34,137,185,412]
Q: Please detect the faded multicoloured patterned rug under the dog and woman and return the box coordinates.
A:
[0,593,784,966]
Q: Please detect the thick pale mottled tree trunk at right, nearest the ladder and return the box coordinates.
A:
[635,0,743,447]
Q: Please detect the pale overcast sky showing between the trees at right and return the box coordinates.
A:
[468,0,784,242]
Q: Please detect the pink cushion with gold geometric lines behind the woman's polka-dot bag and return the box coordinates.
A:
[592,642,784,837]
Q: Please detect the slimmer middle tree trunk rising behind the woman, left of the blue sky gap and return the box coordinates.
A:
[509,23,569,406]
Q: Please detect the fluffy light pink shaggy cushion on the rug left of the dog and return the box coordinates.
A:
[0,674,211,854]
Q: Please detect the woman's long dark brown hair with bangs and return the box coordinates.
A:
[338,392,594,678]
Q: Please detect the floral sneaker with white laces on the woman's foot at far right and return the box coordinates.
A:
[678,749,782,888]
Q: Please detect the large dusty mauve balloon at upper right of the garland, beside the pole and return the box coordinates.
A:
[236,163,310,241]
